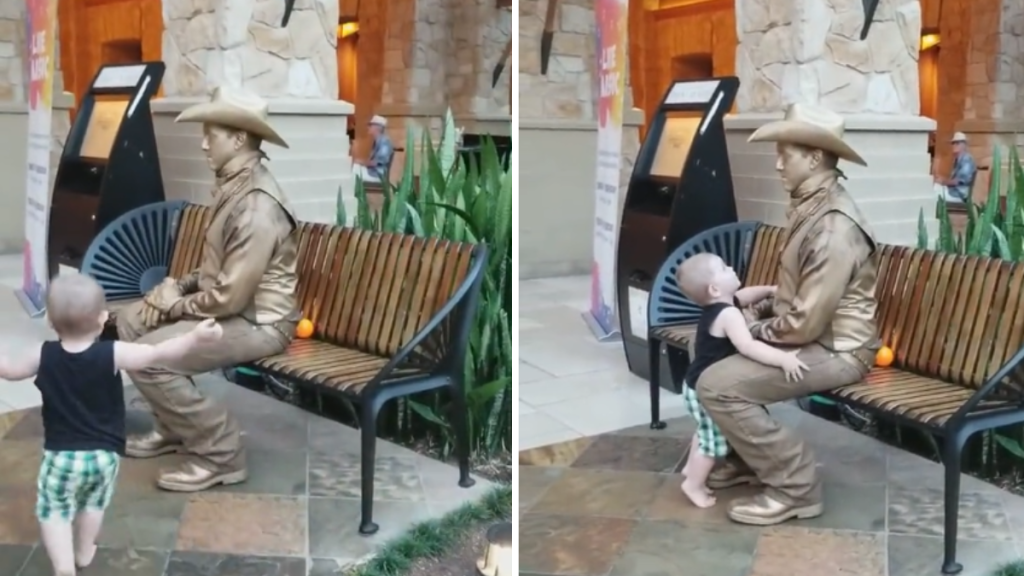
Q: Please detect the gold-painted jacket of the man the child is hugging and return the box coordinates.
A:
[751,172,880,358]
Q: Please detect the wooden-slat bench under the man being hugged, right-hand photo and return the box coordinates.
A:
[651,219,1024,574]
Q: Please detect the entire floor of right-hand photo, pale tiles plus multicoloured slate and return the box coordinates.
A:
[518,278,1024,576]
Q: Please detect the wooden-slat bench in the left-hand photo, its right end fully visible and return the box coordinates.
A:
[83,200,486,535]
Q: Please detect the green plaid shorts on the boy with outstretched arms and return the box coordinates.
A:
[36,450,121,522]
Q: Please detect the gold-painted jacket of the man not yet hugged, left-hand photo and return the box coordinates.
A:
[167,153,300,325]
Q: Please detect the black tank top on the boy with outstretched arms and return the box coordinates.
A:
[36,340,125,456]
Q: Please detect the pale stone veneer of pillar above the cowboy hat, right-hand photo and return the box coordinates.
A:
[736,0,921,116]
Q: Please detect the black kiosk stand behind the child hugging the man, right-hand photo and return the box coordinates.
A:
[615,77,739,393]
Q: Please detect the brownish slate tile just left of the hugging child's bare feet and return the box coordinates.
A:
[532,468,666,518]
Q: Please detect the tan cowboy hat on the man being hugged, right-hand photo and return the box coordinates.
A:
[746,104,867,166]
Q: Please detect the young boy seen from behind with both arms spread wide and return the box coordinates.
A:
[0,274,222,576]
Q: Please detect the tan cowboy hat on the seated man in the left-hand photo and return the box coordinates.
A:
[174,86,288,148]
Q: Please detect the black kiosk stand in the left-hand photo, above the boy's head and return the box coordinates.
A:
[46,63,165,278]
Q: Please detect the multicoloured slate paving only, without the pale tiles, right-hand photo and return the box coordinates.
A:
[519,406,1024,576]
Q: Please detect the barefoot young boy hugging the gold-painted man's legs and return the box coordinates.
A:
[676,253,807,508]
